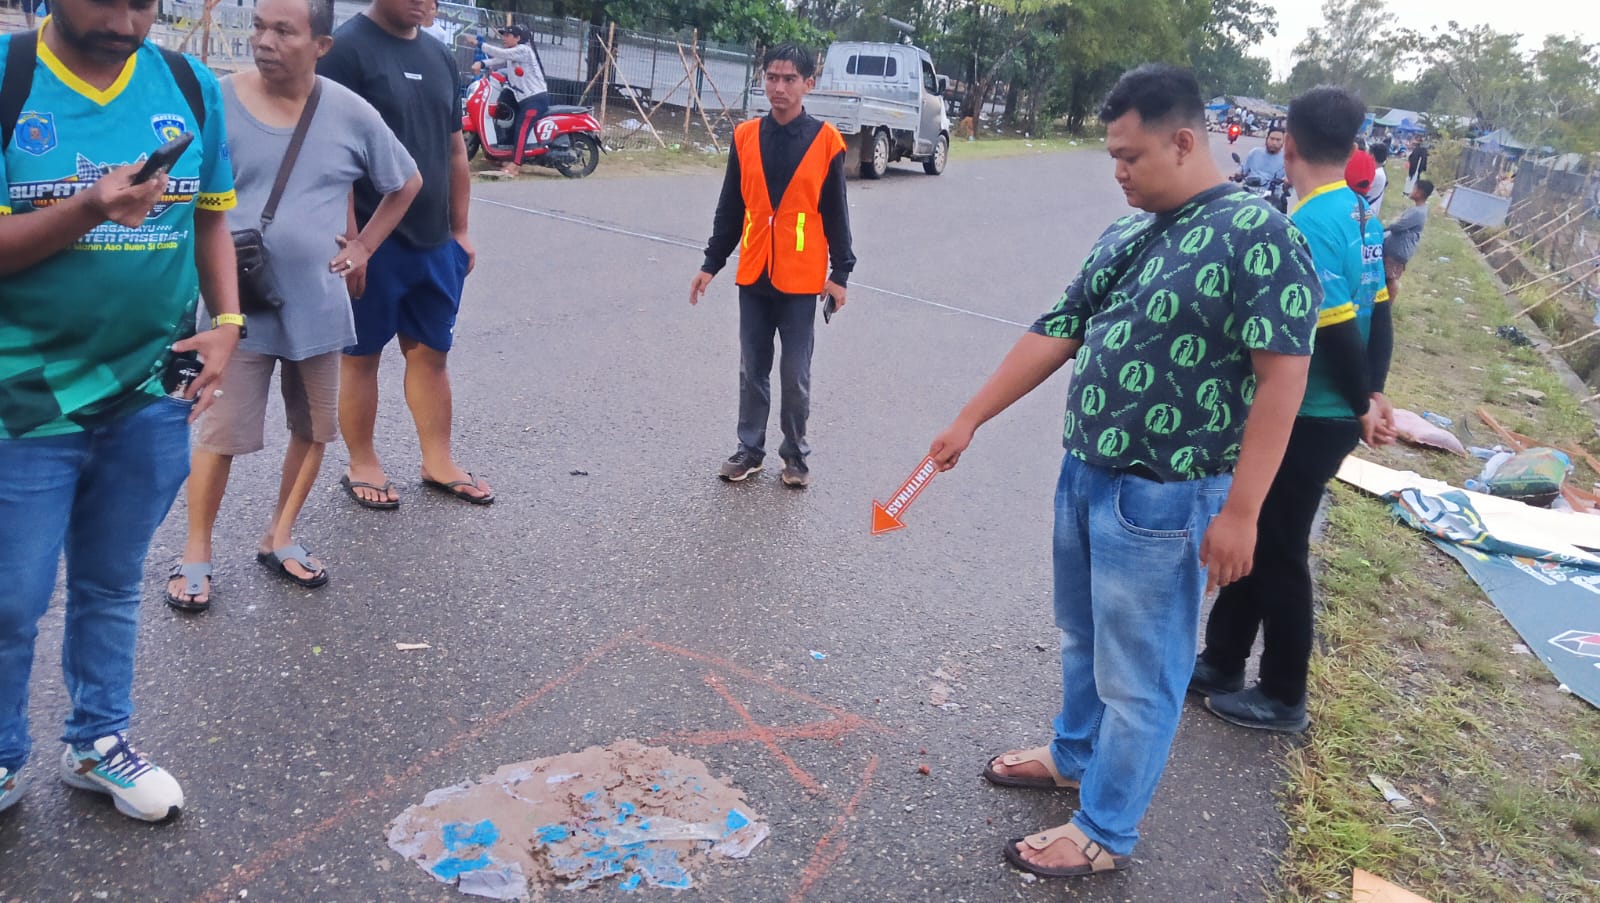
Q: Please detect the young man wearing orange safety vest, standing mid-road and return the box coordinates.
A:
[690,43,856,488]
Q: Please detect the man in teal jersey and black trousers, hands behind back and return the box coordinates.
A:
[1189,88,1394,732]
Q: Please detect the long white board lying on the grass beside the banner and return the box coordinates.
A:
[1339,455,1600,565]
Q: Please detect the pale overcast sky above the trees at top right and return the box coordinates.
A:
[1258,0,1600,78]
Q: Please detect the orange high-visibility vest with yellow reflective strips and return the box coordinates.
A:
[733,118,845,295]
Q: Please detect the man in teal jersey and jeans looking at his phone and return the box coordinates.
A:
[0,0,245,821]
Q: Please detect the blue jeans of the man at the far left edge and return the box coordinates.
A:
[0,397,190,769]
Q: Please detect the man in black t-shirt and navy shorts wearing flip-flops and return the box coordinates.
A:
[317,0,494,508]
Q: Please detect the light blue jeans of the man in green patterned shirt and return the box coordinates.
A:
[1051,455,1234,853]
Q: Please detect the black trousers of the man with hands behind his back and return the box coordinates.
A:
[1200,416,1362,706]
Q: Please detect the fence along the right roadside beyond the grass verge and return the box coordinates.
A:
[1456,147,1600,319]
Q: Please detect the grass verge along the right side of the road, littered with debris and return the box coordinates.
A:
[1277,206,1600,903]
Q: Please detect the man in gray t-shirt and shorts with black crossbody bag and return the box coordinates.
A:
[166,0,422,612]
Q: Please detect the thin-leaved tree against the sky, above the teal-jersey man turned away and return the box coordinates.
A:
[1290,0,1403,98]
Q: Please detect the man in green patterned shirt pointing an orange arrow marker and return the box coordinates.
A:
[930,64,1322,876]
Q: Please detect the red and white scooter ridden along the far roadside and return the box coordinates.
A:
[461,72,602,179]
